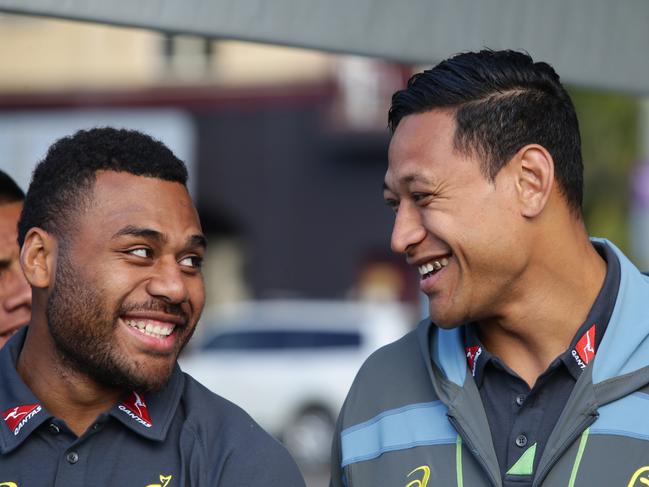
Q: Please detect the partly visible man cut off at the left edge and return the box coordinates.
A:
[0,171,32,348]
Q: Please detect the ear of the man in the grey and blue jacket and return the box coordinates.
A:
[514,144,554,218]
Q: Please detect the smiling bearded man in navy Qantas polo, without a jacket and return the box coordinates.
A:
[0,128,304,487]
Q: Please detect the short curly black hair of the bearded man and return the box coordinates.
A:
[18,127,187,246]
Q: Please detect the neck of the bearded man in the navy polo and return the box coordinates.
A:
[16,324,123,436]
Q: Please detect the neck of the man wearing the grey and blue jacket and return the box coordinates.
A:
[478,239,606,387]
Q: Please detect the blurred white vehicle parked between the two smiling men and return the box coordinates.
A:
[180,301,412,467]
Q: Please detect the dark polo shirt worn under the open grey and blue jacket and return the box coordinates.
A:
[465,243,620,487]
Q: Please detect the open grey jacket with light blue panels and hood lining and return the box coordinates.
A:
[331,240,649,487]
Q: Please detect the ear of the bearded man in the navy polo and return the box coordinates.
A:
[20,227,58,288]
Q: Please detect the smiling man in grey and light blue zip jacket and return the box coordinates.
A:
[331,50,649,487]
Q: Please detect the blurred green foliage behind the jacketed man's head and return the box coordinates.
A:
[569,89,639,252]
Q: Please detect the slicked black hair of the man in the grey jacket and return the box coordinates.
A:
[388,49,583,214]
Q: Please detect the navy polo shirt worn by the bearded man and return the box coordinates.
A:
[0,330,304,487]
